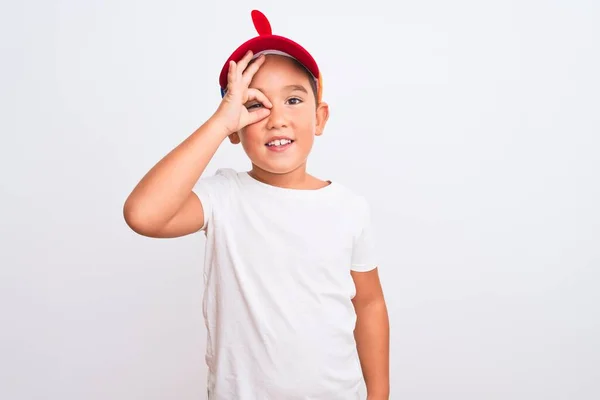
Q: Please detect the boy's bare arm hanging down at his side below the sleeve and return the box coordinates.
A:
[351,268,390,400]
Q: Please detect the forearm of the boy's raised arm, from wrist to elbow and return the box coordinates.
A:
[124,119,227,225]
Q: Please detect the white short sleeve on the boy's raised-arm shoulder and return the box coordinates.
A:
[192,169,236,231]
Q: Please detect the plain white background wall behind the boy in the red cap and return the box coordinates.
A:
[0,0,600,400]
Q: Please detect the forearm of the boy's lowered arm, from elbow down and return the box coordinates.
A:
[354,298,390,400]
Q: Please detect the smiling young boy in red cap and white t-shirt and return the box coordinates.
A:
[124,11,389,400]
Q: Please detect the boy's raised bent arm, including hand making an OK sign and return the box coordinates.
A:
[123,52,271,237]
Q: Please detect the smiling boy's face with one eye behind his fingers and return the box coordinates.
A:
[231,55,328,174]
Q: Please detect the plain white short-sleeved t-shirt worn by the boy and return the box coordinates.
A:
[194,169,376,400]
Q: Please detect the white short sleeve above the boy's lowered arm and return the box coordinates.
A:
[351,200,377,272]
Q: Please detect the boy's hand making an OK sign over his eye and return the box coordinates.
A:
[215,51,272,135]
